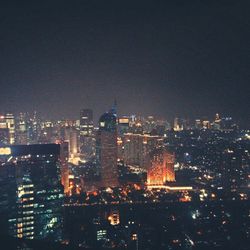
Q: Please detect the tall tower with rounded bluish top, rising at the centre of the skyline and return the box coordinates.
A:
[96,112,118,187]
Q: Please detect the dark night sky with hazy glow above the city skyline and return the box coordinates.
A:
[0,0,250,124]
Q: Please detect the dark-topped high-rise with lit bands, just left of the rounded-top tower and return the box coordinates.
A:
[80,109,95,161]
